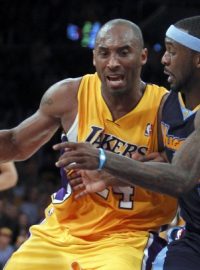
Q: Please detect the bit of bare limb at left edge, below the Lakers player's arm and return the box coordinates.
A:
[0,162,18,190]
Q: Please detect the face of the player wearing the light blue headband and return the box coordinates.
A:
[161,38,195,92]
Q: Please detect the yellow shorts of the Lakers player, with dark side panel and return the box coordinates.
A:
[4,204,166,270]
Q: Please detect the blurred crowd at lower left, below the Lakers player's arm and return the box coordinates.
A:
[0,152,60,269]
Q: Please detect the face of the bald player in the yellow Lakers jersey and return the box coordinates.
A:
[93,25,147,95]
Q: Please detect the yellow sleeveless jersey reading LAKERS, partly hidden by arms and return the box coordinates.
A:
[47,74,176,239]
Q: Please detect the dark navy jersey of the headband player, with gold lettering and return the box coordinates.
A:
[161,91,200,249]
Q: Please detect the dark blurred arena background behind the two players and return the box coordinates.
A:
[0,0,200,266]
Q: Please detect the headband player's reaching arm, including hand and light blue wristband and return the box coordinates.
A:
[54,142,200,197]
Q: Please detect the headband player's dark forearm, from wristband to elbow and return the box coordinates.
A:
[105,152,194,197]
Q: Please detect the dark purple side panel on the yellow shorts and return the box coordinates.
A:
[146,233,167,270]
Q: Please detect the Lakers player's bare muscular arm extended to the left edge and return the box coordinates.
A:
[0,80,79,162]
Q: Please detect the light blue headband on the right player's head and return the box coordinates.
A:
[166,25,200,52]
